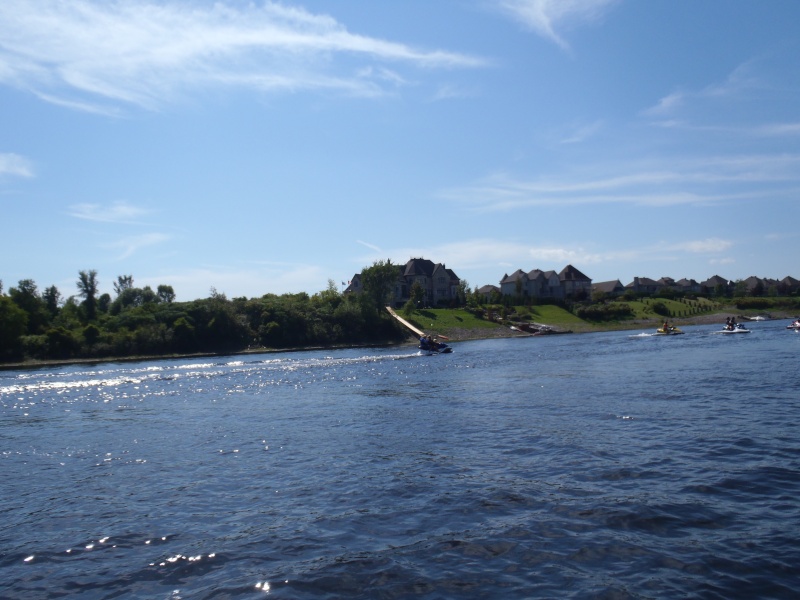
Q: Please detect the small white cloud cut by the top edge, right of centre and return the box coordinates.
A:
[495,0,617,50]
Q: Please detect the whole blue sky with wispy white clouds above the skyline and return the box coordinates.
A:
[0,0,800,301]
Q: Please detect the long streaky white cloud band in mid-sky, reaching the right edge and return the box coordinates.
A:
[440,154,800,212]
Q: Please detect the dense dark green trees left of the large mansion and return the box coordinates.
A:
[0,261,405,362]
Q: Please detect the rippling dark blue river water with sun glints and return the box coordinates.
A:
[0,321,800,600]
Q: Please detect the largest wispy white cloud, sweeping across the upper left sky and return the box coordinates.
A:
[0,0,486,112]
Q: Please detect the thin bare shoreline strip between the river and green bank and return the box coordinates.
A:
[0,311,796,371]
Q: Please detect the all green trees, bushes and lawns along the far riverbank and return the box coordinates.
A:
[0,261,800,365]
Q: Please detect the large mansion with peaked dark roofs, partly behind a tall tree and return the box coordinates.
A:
[344,258,461,307]
